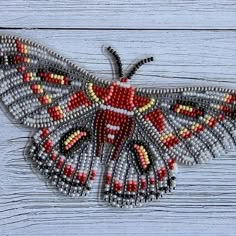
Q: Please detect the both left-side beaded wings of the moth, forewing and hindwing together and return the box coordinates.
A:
[0,35,112,195]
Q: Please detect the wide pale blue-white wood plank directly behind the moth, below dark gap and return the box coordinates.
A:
[0,30,236,235]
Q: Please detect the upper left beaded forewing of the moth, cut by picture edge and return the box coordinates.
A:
[0,35,109,127]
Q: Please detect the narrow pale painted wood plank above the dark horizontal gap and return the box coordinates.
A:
[0,0,236,29]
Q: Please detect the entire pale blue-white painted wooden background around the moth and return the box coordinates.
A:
[0,0,236,236]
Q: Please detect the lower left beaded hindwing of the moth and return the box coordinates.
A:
[29,108,100,196]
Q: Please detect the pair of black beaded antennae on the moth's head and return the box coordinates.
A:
[107,47,154,83]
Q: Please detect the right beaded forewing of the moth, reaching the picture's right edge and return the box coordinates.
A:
[137,87,236,165]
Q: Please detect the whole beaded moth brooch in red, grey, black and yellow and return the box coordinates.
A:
[0,35,236,207]
